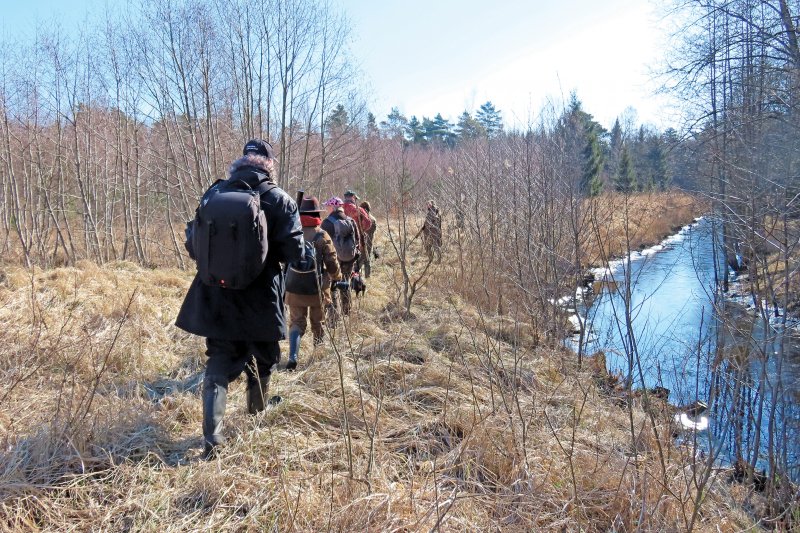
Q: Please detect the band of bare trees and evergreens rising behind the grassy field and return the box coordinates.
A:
[0,0,800,274]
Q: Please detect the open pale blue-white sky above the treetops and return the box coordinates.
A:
[0,0,672,128]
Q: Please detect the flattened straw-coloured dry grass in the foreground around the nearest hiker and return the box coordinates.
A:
[0,234,751,531]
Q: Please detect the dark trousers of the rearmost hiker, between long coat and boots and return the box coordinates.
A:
[206,339,281,388]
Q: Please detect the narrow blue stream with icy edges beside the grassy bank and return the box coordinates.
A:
[570,218,800,480]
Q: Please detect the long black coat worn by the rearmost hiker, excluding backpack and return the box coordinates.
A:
[175,160,303,341]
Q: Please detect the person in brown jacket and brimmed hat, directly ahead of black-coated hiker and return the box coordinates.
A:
[286,196,342,370]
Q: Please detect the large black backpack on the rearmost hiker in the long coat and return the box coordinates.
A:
[187,178,277,289]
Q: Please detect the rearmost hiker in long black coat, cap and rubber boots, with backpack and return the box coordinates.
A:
[175,139,303,458]
